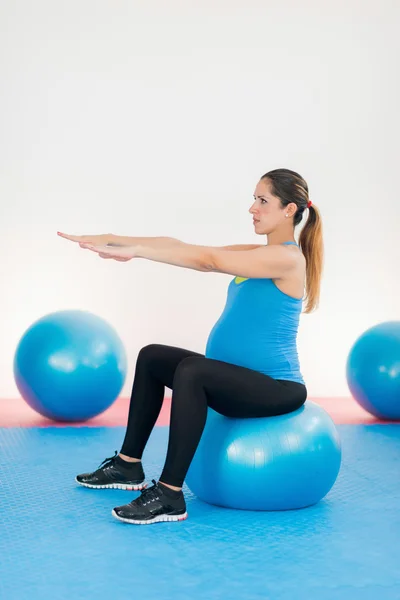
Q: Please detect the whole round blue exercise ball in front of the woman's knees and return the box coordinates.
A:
[14,310,127,422]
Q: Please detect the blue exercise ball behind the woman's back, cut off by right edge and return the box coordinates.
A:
[346,321,400,421]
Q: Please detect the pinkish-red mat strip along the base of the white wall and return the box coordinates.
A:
[0,397,396,427]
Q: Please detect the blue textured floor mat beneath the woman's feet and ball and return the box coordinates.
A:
[0,425,400,600]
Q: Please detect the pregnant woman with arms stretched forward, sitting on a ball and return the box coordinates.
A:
[59,169,323,524]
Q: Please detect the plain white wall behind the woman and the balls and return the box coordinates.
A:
[0,0,400,397]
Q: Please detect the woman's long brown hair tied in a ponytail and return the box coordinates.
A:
[261,169,324,313]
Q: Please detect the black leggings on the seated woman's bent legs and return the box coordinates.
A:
[121,344,307,487]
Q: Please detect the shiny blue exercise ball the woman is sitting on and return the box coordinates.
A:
[186,401,341,510]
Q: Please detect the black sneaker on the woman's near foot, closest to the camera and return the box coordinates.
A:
[111,479,187,525]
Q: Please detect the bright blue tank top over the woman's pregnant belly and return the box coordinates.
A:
[205,242,304,384]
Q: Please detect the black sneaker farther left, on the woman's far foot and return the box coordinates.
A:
[75,452,146,491]
